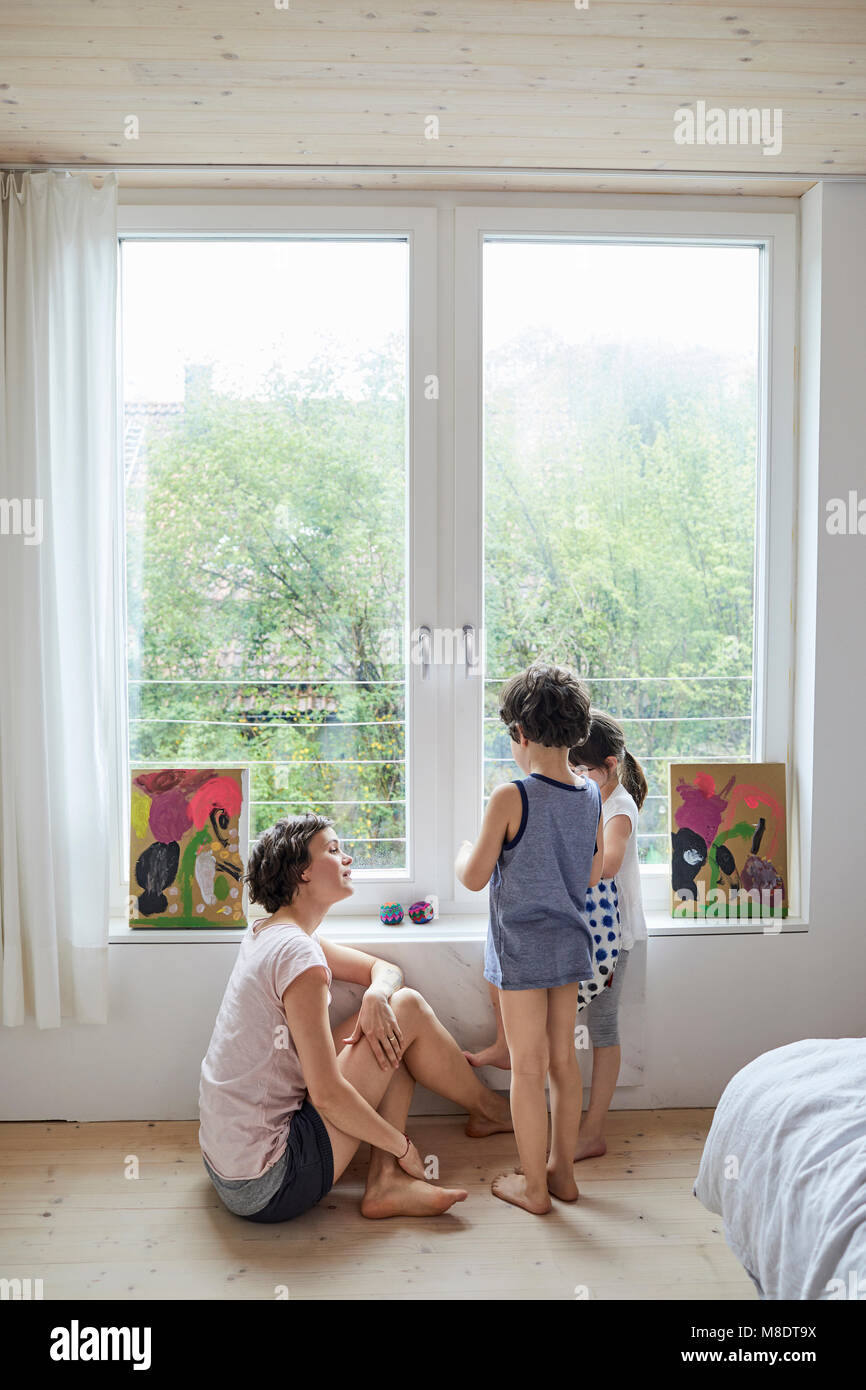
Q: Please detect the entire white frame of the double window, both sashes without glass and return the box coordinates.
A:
[111,192,799,934]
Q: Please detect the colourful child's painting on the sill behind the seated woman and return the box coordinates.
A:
[129,767,249,929]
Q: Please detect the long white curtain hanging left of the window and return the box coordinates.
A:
[0,171,121,1027]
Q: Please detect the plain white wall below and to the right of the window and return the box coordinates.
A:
[0,183,866,1119]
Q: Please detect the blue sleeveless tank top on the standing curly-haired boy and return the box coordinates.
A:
[484,773,602,990]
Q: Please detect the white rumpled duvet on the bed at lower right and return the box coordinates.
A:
[694,1038,866,1300]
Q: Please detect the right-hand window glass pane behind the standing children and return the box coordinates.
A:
[484,239,760,863]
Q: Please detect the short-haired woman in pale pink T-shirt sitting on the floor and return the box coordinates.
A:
[199,815,512,1222]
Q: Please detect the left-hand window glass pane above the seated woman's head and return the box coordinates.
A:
[122,238,409,870]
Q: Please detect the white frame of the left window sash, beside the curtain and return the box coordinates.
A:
[111,203,438,917]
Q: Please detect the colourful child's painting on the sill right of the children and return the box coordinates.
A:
[670,763,788,917]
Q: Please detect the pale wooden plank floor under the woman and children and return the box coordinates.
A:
[0,1111,756,1300]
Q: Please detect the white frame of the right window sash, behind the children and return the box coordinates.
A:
[453,199,799,930]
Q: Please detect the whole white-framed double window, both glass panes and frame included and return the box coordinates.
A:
[117,195,795,913]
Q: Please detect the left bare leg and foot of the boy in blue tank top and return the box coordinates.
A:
[492,990,550,1216]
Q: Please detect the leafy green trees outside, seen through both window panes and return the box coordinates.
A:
[128,336,755,866]
